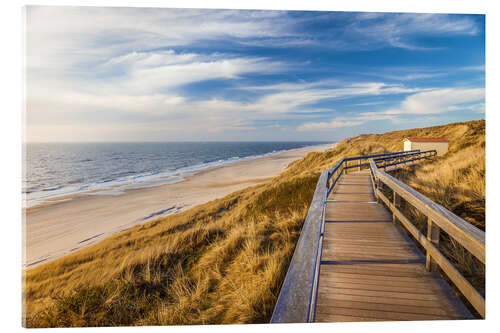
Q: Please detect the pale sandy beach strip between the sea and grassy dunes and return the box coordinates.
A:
[23,144,334,268]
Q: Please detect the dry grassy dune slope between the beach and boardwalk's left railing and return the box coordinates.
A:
[25,175,317,327]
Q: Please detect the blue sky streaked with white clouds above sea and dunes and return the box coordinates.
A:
[25,7,485,141]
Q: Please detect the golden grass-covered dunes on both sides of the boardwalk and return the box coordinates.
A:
[24,120,485,327]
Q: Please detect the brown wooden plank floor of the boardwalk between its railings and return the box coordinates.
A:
[314,170,472,322]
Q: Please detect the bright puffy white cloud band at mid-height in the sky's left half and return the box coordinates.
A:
[27,50,286,98]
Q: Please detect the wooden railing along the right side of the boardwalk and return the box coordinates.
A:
[370,159,485,318]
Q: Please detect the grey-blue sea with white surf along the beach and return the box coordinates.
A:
[22,142,327,207]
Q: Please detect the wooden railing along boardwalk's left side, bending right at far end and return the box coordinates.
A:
[271,150,428,323]
